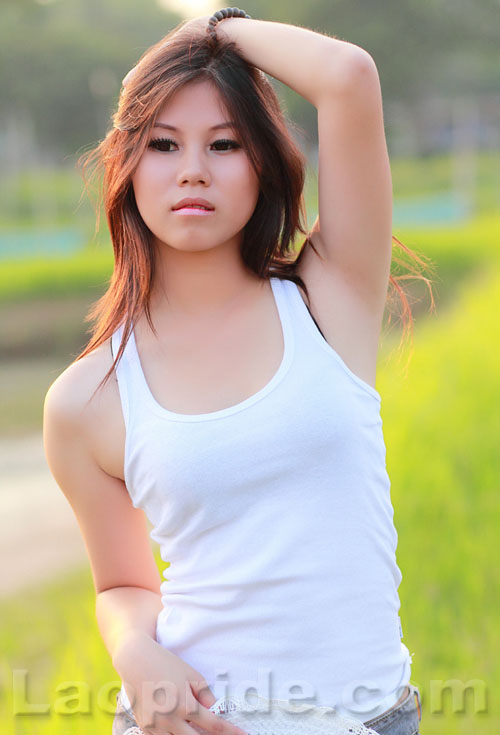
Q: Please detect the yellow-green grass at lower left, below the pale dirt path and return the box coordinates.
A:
[1,568,127,735]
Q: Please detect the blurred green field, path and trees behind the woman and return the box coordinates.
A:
[0,0,500,735]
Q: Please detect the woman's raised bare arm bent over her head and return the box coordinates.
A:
[221,18,393,310]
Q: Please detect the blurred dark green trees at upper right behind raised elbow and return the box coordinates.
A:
[245,0,500,100]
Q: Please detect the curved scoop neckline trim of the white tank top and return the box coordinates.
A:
[129,276,294,422]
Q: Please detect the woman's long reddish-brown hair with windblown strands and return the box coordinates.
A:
[75,22,434,390]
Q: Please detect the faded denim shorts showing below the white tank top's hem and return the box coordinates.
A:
[112,684,422,735]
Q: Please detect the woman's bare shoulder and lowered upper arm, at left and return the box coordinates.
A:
[43,341,161,594]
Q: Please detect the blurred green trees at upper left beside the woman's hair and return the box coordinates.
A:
[0,0,179,157]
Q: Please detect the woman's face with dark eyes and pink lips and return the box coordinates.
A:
[132,80,259,251]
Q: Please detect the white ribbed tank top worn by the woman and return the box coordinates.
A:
[112,277,411,722]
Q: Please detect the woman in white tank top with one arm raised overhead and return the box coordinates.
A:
[44,7,430,735]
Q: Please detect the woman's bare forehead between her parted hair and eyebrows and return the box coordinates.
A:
[156,80,229,130]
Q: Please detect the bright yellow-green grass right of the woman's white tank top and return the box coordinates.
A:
[378,264,500,735]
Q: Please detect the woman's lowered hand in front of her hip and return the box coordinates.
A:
[113,635,246,735]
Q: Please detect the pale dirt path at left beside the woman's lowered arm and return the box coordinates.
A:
[0,433,88,598]
